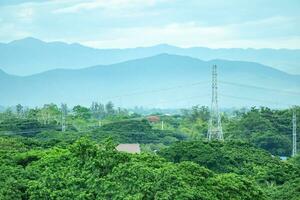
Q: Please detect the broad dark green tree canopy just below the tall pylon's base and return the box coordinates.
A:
[159,141,300,185]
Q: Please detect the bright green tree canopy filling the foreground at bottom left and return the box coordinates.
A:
[0,138,274,200]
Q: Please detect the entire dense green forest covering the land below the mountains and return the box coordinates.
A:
[0,102,300,200]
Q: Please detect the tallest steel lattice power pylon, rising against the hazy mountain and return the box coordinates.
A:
[207,65,224,141]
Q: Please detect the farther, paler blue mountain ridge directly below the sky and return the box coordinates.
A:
[0,38,300,75]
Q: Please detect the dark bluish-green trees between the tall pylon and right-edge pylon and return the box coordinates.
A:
[223,107,300,156]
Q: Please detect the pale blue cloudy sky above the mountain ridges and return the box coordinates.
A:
[0,0,300,49]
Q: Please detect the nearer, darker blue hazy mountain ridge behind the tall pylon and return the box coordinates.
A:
[0,54,300,108]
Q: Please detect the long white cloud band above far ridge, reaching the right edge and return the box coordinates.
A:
[81,22,300,48]
